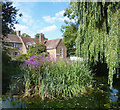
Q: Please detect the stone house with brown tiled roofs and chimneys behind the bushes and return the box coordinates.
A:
[3,31,67,59]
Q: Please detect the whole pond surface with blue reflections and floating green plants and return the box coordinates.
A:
[0,78,120,110]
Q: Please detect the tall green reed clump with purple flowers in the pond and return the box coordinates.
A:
[10,55,93,100]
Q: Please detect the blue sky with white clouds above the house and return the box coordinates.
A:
[13,2,69,39]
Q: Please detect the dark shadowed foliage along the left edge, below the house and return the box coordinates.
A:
[2,50,20,94]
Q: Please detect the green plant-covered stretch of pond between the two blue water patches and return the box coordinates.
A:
[26,90,109,110]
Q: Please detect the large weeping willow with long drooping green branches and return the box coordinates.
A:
[71,2,120,87]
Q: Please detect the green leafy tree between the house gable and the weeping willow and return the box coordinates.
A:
[61,7,78,56]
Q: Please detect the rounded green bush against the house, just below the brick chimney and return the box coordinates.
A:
[27,43,46,58]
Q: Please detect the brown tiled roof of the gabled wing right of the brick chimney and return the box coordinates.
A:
[46,39,62,49]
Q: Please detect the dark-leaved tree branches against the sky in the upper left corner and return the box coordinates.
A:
[0,1,22,37]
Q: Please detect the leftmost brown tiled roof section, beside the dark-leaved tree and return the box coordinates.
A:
[3,34,22,43]
